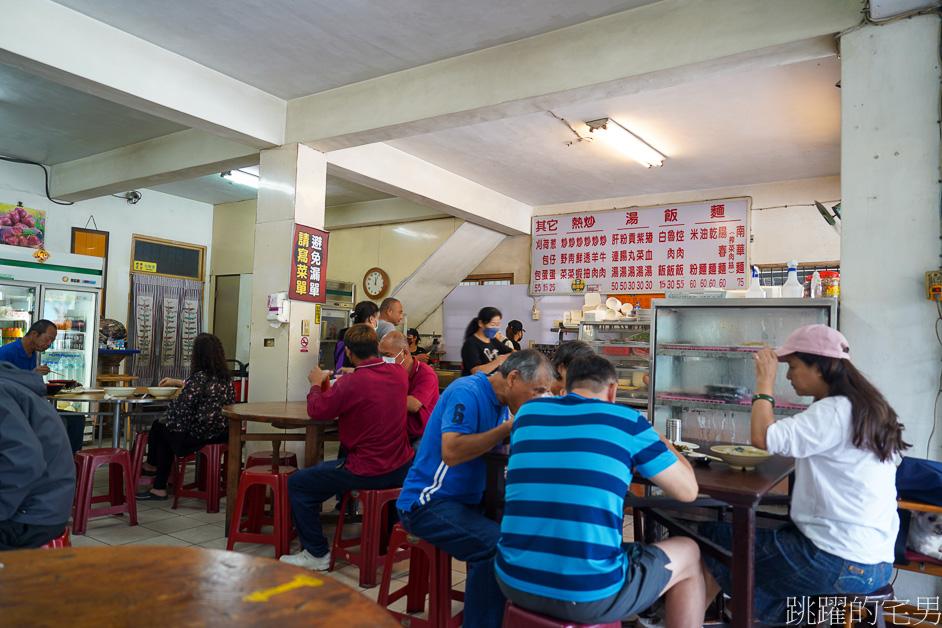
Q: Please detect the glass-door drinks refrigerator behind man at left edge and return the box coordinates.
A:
[0,245,104,387]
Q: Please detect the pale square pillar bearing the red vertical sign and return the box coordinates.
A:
[249,144,330,401]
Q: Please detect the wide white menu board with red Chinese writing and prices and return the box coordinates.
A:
[530,198,749,295]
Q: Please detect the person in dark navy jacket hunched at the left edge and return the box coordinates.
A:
[0,362,75,551]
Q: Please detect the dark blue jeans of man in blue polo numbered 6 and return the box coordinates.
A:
[399,499,507,628]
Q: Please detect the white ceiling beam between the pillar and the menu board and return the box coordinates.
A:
[327,144,533,235]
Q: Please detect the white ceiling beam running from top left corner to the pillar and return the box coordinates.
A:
[0,0,286,149]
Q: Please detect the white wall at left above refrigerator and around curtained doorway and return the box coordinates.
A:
[0,161,213,329]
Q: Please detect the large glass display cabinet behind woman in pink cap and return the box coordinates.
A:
[648,298,837,444]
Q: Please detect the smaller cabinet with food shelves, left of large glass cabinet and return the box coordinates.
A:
[579,319,651,411]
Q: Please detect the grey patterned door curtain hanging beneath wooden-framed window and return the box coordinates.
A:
[127,273,203,386]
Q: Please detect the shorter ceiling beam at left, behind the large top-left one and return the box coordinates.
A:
[49,129,259,201]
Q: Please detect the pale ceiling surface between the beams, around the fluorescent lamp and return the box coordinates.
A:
[0,0,840,211]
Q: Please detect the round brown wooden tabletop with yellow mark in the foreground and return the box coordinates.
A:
[0,546,399,628]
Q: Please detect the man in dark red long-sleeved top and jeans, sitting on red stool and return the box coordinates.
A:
[281,324,413,571]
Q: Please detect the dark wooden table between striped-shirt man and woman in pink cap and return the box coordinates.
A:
[484,441,795,628]
